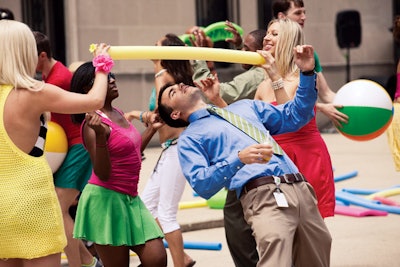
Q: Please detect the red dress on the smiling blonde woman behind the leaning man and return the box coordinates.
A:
[273,103,336,218]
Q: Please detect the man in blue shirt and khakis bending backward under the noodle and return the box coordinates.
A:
[158,45,332,267]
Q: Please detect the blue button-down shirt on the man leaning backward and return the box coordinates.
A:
[178,75,317,199]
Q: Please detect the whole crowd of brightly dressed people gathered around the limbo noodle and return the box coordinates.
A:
[0,0,400,267]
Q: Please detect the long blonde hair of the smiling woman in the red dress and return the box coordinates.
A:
[268,18,304,77]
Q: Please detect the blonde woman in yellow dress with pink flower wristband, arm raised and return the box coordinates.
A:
[0,20,109,267]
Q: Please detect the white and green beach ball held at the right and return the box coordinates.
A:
[333,79,393,141]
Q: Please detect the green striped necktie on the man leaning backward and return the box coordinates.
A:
[207,106,283,155]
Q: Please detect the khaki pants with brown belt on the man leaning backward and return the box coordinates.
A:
[240,182,332,267]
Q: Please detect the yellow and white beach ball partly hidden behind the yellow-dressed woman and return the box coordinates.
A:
[44,121,68,173]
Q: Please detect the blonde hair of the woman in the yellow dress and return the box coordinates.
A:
[0,20,38,89]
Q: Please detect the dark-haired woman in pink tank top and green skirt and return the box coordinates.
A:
[71,62,167,267]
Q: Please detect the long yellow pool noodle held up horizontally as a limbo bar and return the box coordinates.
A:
[108,46,265,65]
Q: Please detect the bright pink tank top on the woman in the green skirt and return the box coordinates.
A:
[82,109,142,196]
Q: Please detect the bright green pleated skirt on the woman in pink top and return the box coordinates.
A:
[74,184,164,246]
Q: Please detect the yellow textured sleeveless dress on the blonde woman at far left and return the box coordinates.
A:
[0,85,67,260]
